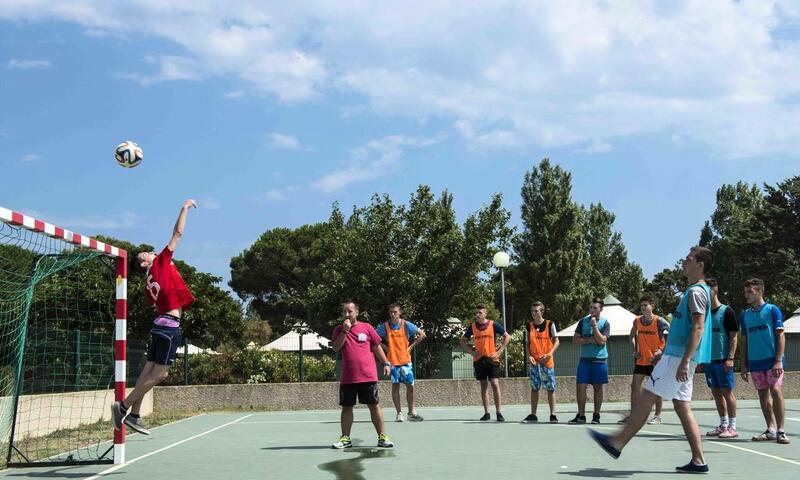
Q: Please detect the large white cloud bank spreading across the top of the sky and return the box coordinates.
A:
[0,0,800,157]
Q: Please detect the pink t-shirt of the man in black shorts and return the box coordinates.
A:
[331,322,381,385]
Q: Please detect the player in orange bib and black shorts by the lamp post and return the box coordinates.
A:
[461,305,511,422]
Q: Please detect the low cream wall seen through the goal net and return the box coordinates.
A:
[15,389,153,438]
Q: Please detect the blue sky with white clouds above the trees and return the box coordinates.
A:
[0,0,800,290]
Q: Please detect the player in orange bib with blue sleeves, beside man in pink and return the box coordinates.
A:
[375,303,425,422]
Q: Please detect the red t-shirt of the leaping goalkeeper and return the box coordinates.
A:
[145,247,194,313]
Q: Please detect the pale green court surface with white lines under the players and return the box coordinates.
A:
[0,400,800,480]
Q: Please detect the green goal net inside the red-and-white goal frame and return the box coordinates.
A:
[0,222,115,464]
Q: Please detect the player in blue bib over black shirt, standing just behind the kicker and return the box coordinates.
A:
[704,278,739,439]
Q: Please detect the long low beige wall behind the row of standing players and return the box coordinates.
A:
[153,372,800,411]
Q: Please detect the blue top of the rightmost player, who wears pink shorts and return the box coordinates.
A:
[741,303,786,372]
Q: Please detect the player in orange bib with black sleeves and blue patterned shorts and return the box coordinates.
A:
[523,302,559,423]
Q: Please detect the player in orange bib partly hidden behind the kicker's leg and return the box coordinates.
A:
[617,295,669,425]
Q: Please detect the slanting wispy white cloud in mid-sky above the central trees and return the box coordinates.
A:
[311,135,442,193]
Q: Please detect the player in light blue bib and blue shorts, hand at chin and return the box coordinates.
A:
[567,298,611,425]
